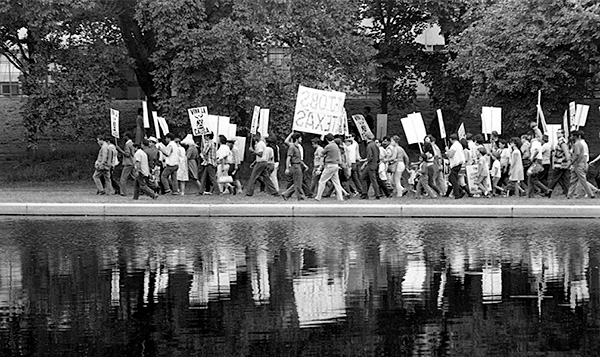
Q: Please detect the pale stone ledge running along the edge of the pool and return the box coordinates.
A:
[0,203,600,218]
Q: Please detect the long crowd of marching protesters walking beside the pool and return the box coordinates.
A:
[93,119,600,201]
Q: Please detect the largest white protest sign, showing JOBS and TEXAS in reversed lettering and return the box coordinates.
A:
[292,86,344,135]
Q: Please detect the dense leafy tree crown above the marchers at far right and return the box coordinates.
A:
[449,0,600,132]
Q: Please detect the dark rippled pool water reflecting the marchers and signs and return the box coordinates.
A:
[0,218,600,356]
